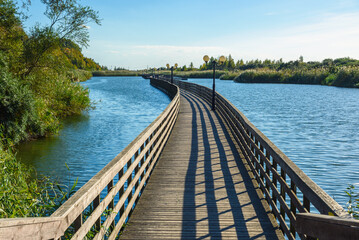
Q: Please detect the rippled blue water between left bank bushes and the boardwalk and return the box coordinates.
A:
[18,77,170,187]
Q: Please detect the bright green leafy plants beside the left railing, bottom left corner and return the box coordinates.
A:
[0,137,77,218]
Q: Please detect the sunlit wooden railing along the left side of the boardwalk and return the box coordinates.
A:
[0,79,180,239]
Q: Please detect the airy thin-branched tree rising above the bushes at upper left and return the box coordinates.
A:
[23,0,101,77]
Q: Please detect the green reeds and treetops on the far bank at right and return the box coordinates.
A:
[197,55,359,87]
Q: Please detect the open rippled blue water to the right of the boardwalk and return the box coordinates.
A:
[189,79,359,205]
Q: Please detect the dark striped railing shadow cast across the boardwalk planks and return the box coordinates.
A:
[182,91,282,239]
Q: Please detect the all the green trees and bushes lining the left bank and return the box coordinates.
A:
[0,0,100,217]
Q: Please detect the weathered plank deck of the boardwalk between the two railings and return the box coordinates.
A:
[120,90,283,239]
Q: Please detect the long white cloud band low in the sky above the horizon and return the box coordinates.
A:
[86,12,359,69]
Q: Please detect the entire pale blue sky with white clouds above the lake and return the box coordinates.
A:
[26,0,359,69]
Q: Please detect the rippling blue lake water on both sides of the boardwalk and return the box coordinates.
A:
[19,77,359,205]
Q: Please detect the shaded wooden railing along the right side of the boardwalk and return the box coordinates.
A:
[174,81,358,239]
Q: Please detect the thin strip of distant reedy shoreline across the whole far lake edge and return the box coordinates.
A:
[92,67,359,88]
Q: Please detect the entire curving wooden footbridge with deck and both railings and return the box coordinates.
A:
[0,77,359,239]
